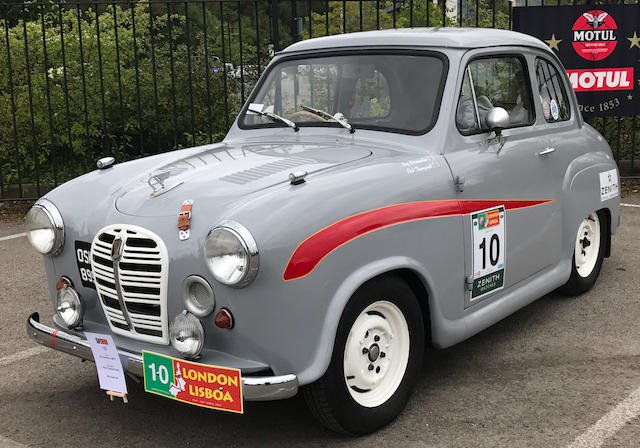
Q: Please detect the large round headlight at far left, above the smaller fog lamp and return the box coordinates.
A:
[25,199,64,255]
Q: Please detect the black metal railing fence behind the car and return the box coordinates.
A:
[0,0,638,200]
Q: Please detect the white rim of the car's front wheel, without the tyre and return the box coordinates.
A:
[344,300,410,408]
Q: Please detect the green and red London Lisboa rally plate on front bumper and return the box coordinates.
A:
[142,351,244,414]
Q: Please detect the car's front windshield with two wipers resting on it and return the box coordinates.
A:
[240,52,445,134]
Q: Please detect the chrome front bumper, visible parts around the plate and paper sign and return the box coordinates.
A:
[27,313,298,401]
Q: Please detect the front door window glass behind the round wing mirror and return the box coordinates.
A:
[456,56,534,134]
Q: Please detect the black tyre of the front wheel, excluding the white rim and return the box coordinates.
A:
[304,276,425,435]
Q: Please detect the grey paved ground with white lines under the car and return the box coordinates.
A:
[0,200,640,448]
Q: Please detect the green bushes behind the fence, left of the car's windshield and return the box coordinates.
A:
[0,3,268,184]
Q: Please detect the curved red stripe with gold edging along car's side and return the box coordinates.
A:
[282,199,552,281]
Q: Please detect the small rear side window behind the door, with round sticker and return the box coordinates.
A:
[536,59,571,123]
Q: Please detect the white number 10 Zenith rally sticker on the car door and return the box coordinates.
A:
[471,205,507,300]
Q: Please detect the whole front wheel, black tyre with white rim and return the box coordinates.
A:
[304,277,425,435]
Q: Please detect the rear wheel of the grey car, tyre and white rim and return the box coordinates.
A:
[560,211,609,296]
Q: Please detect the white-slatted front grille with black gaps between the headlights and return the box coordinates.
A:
[91,225,169,344]
